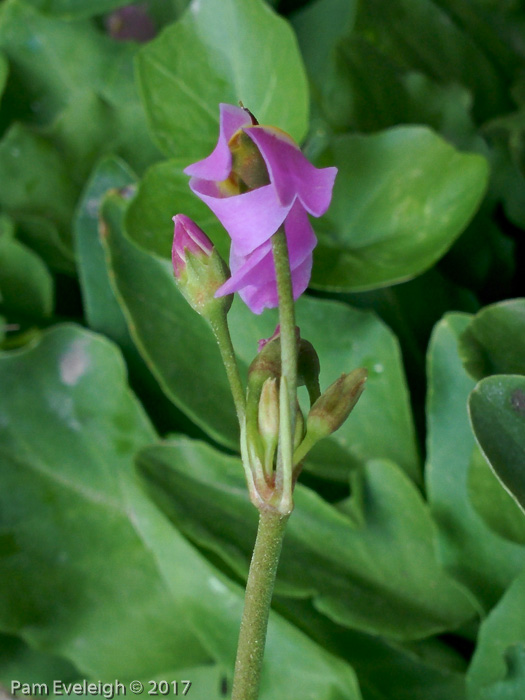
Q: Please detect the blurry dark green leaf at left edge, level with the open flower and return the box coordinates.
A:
[0,124,78,253]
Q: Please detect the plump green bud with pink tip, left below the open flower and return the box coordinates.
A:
[172,214,233,318]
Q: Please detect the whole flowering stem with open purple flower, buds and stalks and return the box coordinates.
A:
[173,104,367,700]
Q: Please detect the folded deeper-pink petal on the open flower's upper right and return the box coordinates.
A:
[244,126,337,216]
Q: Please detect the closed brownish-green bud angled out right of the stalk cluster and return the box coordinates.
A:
[306,367,368,442]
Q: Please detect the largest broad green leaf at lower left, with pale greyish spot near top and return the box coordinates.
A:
[0,326,361,700]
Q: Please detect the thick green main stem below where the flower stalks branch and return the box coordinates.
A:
[232,509,289,700]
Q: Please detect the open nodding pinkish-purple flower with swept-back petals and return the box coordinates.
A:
[185,104,337,314]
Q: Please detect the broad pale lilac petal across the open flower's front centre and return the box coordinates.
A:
[190,178,291,255]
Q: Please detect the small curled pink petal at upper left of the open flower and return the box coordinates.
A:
[184,104,252,181]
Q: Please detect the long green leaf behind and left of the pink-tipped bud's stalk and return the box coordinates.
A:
[101,194,238,449]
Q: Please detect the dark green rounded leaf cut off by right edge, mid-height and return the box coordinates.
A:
[469,374,525,520]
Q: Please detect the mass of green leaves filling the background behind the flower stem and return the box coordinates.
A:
[0,0,525,700]
